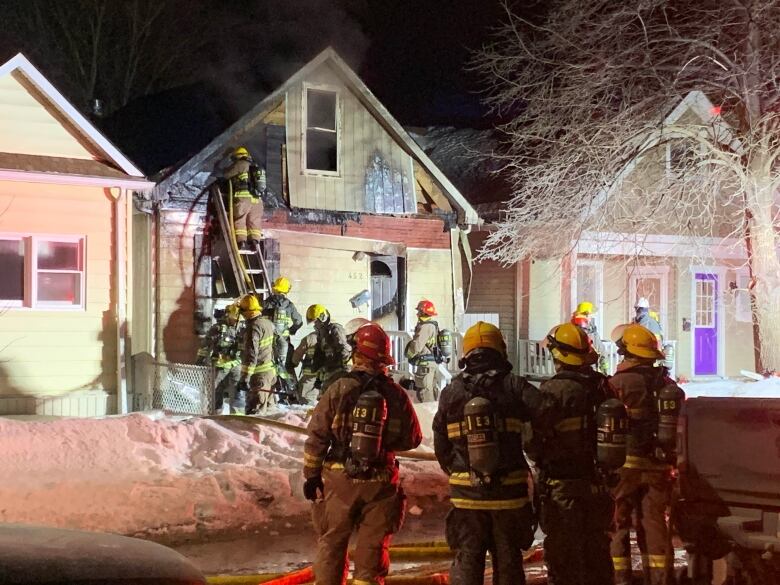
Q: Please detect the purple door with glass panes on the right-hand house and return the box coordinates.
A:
[693,272,718,376]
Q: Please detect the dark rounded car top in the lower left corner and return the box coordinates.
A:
[0,524,206,585]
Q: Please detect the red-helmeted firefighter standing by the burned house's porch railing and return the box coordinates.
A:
[404,300,439,402]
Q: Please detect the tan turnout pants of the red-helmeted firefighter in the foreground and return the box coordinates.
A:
[312,469,406,585]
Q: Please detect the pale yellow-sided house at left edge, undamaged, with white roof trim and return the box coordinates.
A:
[0,54,152,416]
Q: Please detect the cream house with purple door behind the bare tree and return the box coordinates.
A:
[466,91,755,379]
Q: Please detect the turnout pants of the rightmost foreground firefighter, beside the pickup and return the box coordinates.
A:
[610,467,672,585]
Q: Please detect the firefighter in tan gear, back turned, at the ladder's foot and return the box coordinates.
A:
[237,294,276,414]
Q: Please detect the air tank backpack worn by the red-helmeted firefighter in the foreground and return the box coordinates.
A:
[344,378,387,478]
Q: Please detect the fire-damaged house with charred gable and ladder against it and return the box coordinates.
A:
[134,49,479,363]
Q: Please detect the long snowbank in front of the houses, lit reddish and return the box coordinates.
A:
[0,413,446,538]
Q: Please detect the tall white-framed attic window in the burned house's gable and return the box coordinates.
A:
[304,87,339,175]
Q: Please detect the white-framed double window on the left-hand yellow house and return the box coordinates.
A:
[0,234,84,309]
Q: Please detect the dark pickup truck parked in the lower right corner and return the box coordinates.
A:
[673,398,780,585]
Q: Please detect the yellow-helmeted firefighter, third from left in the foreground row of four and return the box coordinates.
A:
[527,323,613,585]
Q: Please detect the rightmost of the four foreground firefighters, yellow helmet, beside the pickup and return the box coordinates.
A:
[610,323,684,585]
